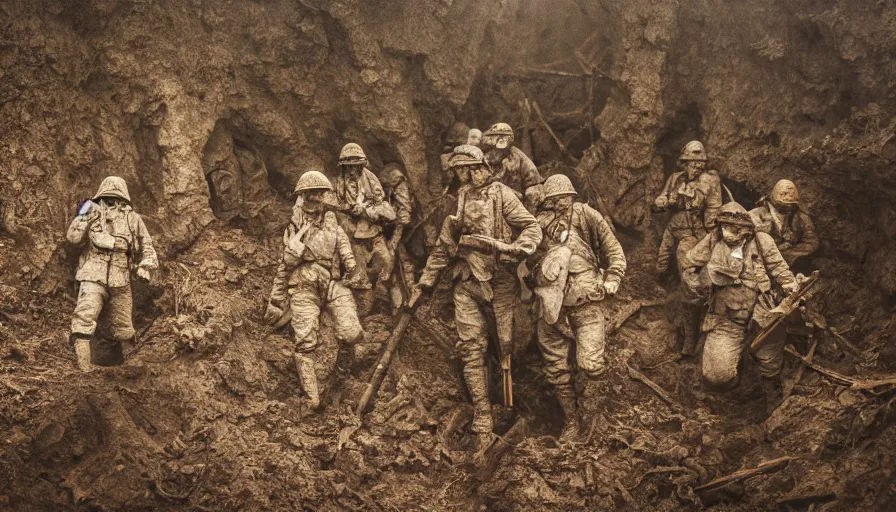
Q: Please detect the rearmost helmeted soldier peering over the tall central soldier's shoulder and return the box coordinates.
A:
[482,123,544,207]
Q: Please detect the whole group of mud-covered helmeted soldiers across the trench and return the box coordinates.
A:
[68,123,818,439]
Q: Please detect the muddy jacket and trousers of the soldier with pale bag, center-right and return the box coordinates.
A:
[536,203,626,387]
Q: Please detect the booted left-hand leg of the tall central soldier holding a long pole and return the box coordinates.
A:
[454,280,493,434]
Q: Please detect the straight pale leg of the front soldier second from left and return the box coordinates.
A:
[289,283,321,409]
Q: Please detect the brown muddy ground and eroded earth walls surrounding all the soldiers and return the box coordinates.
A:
[0,0,896,511]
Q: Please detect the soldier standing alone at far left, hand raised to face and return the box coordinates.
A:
[67,176,159,371]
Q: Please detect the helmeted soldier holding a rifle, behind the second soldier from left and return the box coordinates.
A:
[335,143,395,316]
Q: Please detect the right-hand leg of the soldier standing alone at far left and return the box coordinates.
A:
[92,284,136,366]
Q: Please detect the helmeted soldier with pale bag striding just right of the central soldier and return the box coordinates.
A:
[533,174,626,440]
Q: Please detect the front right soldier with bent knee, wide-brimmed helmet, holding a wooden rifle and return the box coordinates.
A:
[682,202,799,411]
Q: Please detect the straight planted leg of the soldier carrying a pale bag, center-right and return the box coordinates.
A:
[536,316,579,440]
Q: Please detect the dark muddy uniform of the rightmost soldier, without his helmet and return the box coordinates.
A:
[750,199,819,265]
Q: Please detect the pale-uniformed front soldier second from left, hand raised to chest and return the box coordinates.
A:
[265,171,364,409]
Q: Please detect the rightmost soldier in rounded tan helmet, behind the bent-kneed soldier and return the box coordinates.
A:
[750,180,818,266]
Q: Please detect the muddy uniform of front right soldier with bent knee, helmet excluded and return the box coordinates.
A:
[683,221,796,387]
